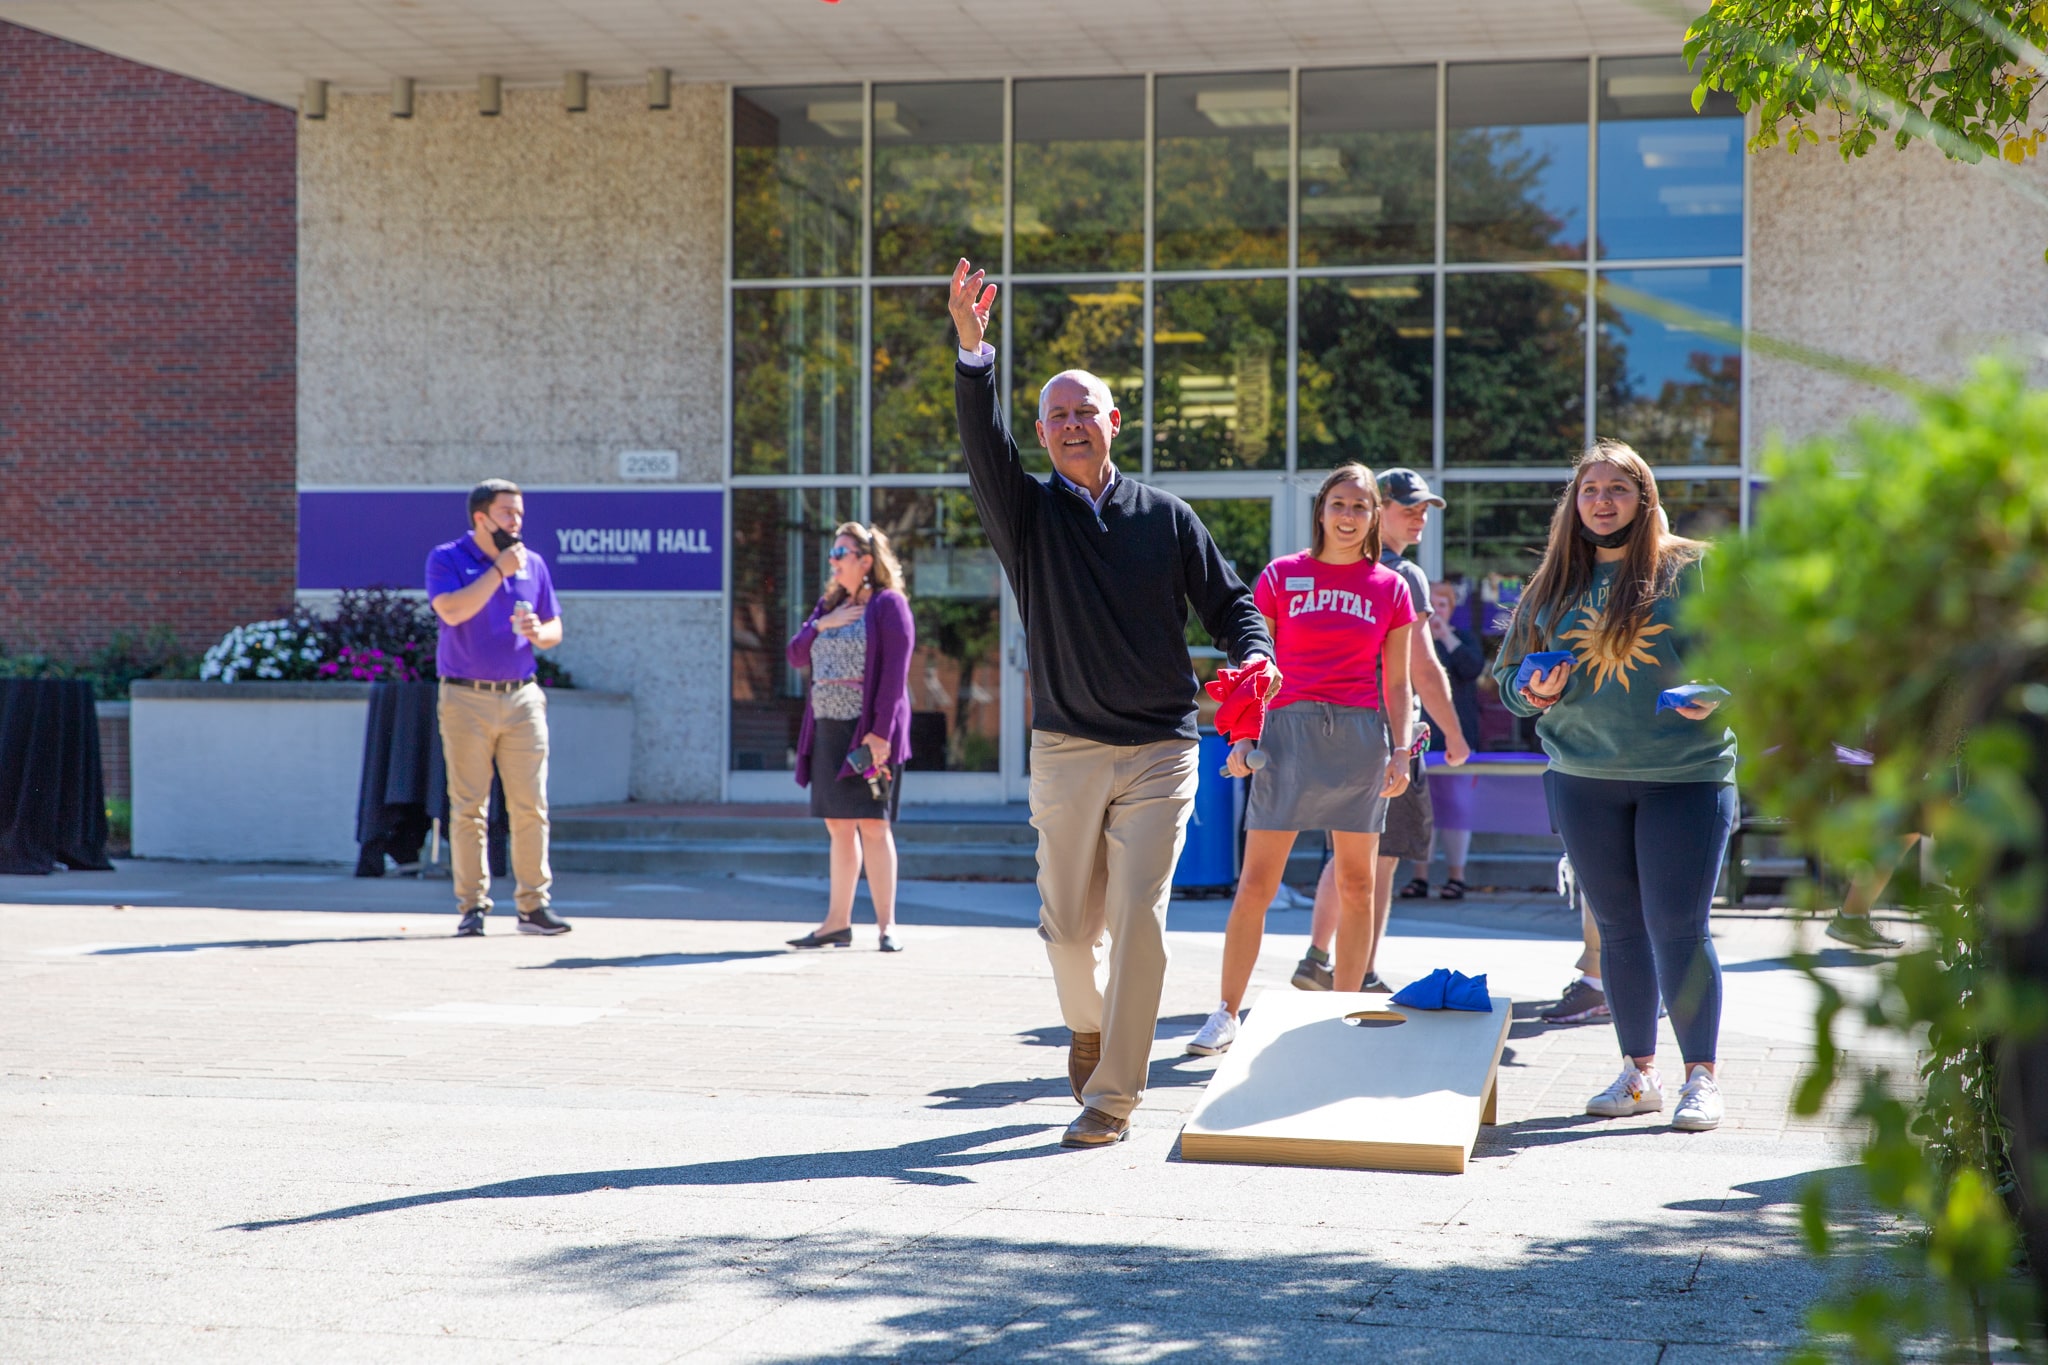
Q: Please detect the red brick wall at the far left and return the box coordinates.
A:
[0,23,297,657]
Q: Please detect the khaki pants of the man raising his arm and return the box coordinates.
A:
[1030,731,1200,1119]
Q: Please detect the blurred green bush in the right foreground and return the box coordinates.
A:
[1694,362,2048,1361]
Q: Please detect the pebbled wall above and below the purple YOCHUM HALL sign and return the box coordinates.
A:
[299,86,727,800]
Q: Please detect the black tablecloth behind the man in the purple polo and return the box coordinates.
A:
[356,681,512,876]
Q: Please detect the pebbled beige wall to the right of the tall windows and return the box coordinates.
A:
[1749,141,2048,442]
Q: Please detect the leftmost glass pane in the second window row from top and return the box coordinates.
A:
[733,289,860,475]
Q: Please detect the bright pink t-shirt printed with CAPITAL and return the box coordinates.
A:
[1251,551,1415,710]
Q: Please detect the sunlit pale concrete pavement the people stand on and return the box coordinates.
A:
[0,864,1916,1365]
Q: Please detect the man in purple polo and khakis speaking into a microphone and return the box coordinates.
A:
[426,479,569,937]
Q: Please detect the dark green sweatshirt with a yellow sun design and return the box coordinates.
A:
[1493,563,1735,782]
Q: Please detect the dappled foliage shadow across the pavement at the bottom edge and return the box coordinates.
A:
[508,1214,1859,1365]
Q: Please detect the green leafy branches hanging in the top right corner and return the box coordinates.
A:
[1686,0,2048,164]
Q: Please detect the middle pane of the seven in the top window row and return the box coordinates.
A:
[1153,72,1292,270]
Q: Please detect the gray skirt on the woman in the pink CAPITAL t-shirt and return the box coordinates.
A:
[1245,702,1386,835]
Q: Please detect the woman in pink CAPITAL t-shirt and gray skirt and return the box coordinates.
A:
[1188,465,1415,1056]
